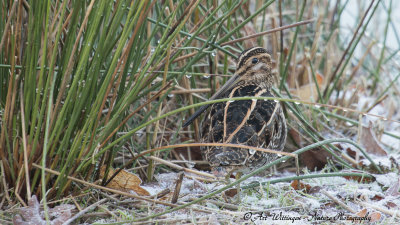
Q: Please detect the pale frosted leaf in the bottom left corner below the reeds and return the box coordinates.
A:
[13,195,75,225]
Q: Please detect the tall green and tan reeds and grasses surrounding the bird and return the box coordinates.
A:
[0,0,400,221]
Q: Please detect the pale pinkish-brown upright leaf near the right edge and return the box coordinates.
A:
[360,123,387,156]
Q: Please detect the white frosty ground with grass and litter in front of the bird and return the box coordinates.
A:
[90,172,400,224]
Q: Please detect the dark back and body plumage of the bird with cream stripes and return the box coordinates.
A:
[201,85,286,171]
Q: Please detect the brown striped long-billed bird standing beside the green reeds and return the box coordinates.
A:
[183,47,287,177]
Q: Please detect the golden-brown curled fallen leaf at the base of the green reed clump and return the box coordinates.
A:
[100,165,150,196]
